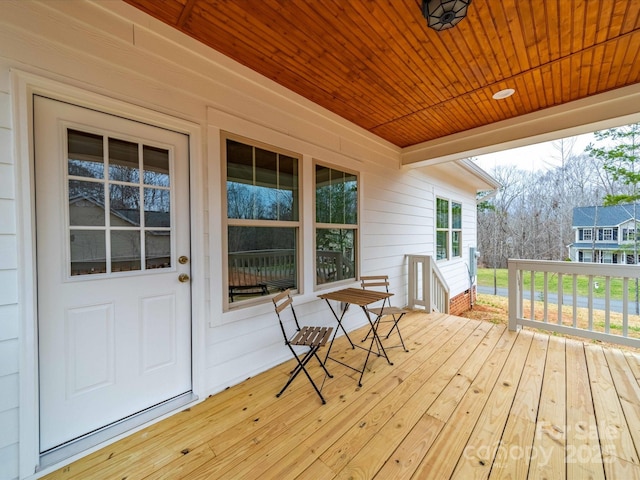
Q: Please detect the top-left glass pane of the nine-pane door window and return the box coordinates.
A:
[67,130,104,178]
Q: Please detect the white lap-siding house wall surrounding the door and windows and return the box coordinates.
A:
[0,1,488,479]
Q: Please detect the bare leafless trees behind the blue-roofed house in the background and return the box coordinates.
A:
[478,123,640,268]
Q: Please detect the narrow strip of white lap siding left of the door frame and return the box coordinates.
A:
[0,83,20,479]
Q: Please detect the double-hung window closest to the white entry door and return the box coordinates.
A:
[224,138,300,303]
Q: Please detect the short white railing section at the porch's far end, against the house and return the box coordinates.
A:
[407,255,449,313]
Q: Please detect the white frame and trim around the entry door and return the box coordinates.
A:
[11,70,206,478]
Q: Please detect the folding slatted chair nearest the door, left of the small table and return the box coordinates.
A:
[272,289,333,404]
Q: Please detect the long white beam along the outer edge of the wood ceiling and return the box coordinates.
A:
[401,84,640,168]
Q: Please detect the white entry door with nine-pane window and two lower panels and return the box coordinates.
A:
[34,97,192,452]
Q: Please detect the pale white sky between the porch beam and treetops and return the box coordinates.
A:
[476,133,593,172]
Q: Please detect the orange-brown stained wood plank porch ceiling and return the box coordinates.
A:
[125,0,640,147]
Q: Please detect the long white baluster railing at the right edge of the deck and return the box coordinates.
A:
[508,259,640,347]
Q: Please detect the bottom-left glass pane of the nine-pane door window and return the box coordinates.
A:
[69,230,107,275]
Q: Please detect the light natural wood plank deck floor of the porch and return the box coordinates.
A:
[41,313,640,480]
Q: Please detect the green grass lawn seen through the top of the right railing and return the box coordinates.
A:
[478,268,636,300]
